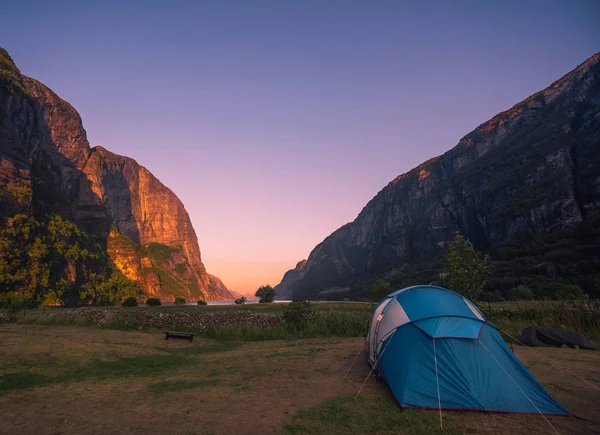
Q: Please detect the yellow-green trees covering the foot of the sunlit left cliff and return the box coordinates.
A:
[0,214,139,305]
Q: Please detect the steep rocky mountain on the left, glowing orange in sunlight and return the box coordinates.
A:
[0,49,231,300]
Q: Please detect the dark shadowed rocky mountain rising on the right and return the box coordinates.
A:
[280,53,600,298]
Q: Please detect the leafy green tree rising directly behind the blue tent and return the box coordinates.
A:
[444,232,489,301]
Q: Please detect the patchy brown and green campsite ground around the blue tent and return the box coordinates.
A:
[0,324,600,434]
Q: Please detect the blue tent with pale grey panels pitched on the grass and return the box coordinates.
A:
[367,285,570,415]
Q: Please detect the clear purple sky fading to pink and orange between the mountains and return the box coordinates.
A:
[0,0,600,292]
